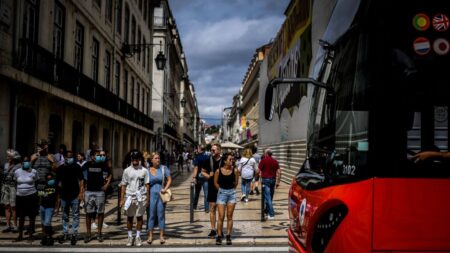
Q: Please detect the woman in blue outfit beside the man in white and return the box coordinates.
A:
[147,152,172,244]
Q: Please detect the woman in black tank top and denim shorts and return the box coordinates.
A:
[214,153,239,245]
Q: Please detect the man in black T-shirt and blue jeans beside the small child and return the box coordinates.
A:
[56,151,84,245]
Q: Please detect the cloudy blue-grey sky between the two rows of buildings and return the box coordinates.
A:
[169,0,289,124]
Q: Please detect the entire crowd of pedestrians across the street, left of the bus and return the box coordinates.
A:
[1,140,280,246]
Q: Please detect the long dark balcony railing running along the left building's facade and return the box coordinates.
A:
[14,40,153,130]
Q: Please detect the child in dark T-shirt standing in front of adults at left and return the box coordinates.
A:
[38,173,58,246]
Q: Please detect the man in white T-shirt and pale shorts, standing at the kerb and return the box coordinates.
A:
[120,151,150,246]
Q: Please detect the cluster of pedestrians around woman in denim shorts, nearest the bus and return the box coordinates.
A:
[192,144,281,245]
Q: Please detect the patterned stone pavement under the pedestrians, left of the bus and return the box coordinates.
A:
[0,167,289,247]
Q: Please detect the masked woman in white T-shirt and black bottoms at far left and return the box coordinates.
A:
[14,157,39,241]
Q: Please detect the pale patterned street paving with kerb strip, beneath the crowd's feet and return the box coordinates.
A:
[0,166,289,249]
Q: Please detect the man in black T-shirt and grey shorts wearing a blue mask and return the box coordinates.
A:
[84,150,112,243]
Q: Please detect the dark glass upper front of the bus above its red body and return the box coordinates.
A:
[297,0,450,187]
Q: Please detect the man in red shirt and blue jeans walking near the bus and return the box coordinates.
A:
[259,148,281,220]
